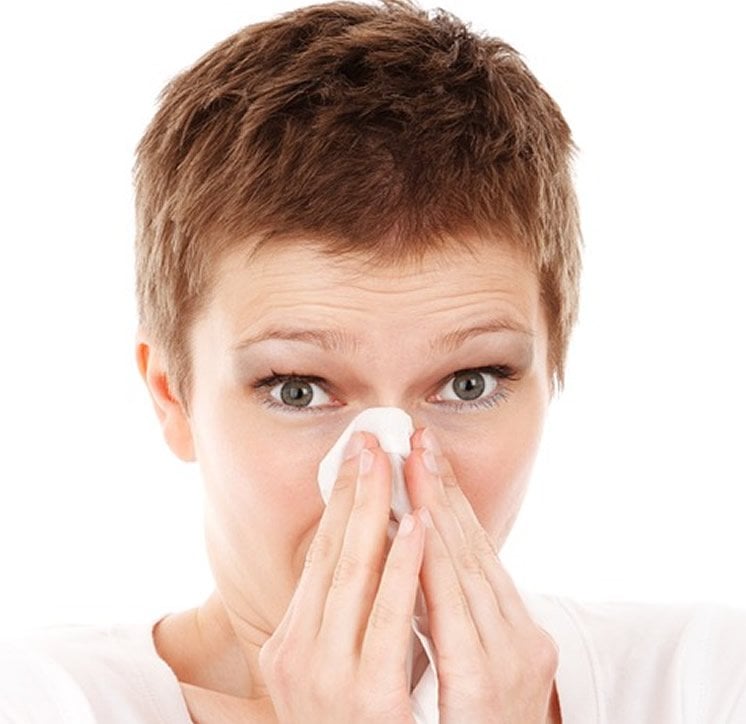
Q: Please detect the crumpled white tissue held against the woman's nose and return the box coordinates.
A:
[318,407,438,724]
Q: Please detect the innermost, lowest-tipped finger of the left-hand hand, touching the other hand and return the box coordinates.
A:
[360,506,425,673]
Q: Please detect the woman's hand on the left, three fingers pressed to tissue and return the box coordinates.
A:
[259,432,425,724]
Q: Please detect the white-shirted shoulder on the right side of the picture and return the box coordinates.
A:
[529,596,746,722]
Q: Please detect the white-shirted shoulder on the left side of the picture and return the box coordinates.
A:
[0,621,190,724]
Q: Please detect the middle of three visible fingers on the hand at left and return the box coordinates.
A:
[319,447,391,660]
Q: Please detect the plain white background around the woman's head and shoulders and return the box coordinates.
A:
[0,0,746,631]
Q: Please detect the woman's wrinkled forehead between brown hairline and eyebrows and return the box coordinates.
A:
[208,240,541,340]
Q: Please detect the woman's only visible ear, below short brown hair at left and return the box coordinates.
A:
[135,330,197,462]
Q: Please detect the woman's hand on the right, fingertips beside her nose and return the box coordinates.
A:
[405,430,559,724]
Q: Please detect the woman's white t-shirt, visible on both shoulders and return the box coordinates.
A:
[0,593,746,724]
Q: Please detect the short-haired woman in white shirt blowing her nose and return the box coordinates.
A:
[0,2,746,722]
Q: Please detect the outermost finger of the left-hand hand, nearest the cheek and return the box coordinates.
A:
[283,432,378,638]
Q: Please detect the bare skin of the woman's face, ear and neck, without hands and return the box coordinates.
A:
[136,239,560,721]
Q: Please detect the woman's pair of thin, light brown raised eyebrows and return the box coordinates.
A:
[233,317,536,354]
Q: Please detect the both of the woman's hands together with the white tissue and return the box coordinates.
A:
[260,407,561,724]
